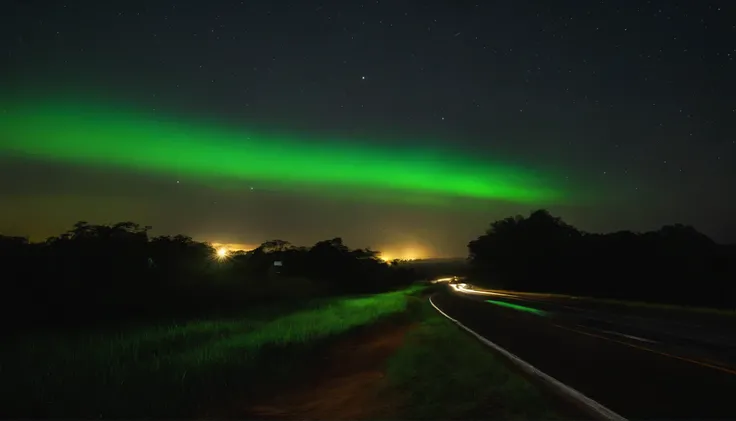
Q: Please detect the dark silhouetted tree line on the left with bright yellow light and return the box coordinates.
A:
[0,221,418,330]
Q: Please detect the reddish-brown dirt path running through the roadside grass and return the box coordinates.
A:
[221,323,413,420]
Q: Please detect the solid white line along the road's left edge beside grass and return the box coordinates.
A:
[429,297,628,421]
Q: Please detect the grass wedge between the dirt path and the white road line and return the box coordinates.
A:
[388,303,563,420]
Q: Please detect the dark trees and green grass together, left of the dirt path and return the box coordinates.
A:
[0,221,472,419]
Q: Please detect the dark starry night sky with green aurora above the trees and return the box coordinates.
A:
[0,0,736,258]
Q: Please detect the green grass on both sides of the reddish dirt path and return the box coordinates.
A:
[0,285,562,420]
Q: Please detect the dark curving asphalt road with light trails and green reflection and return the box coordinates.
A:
[432,284,736,420]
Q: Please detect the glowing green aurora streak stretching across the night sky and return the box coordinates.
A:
[0,97,565,204]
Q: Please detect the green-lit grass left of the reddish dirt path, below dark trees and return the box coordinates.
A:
[0,288,426,418]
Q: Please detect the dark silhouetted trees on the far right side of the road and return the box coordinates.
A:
[468,209,736,308]
